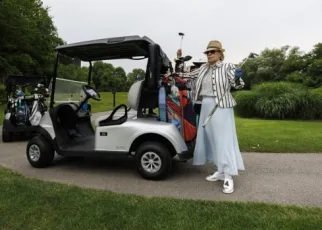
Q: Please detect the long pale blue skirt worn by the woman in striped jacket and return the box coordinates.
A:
[193,97,245,176]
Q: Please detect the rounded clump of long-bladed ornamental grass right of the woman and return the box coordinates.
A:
[234,82,322,120]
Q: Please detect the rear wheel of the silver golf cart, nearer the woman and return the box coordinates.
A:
[135,142,172,180]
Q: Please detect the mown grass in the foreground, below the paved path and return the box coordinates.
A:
[0,168,322,230]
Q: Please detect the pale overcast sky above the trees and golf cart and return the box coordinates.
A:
[43,0,322,72]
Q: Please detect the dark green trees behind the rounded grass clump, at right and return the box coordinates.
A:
[242,43,322,89]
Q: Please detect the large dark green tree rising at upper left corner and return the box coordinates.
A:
[0,0,64,81]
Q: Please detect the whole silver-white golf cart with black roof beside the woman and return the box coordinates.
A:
[26,36,193,180]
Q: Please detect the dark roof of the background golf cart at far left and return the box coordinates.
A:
[5,75,47,90]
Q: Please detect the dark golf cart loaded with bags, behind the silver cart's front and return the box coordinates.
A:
[2,75,48,142]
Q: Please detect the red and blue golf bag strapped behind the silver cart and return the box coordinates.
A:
[160,74,197,142]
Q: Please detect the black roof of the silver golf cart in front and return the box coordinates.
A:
[56,35,174,65]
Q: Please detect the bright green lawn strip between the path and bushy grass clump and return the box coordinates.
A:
[236,117,322,153]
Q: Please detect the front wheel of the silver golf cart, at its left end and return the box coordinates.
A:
[27,136,55,168]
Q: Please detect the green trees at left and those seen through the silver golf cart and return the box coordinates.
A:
[0,0,145,95]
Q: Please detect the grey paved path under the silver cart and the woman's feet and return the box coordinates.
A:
[0,114,322,207]
